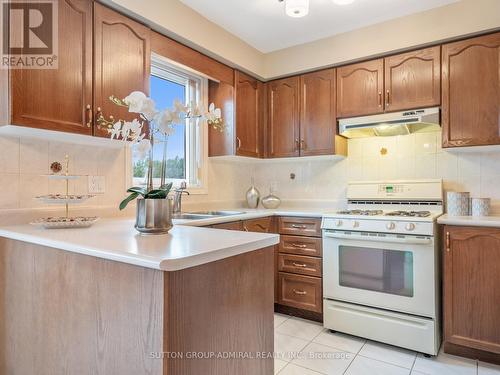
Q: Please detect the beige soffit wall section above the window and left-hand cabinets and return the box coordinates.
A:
[107,0,264,77]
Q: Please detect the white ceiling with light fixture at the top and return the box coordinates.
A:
[180,0,459,53]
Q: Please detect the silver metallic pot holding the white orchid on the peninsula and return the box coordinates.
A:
[135,197,174,234]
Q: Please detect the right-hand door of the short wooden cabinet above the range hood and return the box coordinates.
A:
[384,46,441,112]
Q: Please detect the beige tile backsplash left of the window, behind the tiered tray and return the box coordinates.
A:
[0,136,126,209]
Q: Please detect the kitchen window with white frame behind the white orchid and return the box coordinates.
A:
[131,54,208,193]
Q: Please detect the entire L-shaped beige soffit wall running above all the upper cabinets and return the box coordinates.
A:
[109,0,500,79]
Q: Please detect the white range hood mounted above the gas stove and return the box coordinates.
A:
[339,107,441,138]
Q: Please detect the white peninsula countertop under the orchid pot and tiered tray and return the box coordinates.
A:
[0,219,279,271]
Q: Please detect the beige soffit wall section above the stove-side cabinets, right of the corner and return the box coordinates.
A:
[264,0,500,77]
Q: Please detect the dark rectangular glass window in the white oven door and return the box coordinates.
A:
[339,246,413,297]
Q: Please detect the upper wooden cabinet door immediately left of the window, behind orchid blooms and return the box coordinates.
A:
[94,3,151,137]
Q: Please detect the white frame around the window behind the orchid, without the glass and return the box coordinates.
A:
[127,53,208,194]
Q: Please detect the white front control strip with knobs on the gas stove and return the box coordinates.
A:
[322,217,434,236]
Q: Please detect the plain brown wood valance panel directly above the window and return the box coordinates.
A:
[151,32,234,86]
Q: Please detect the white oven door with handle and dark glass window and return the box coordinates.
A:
[323,230,436,318]
